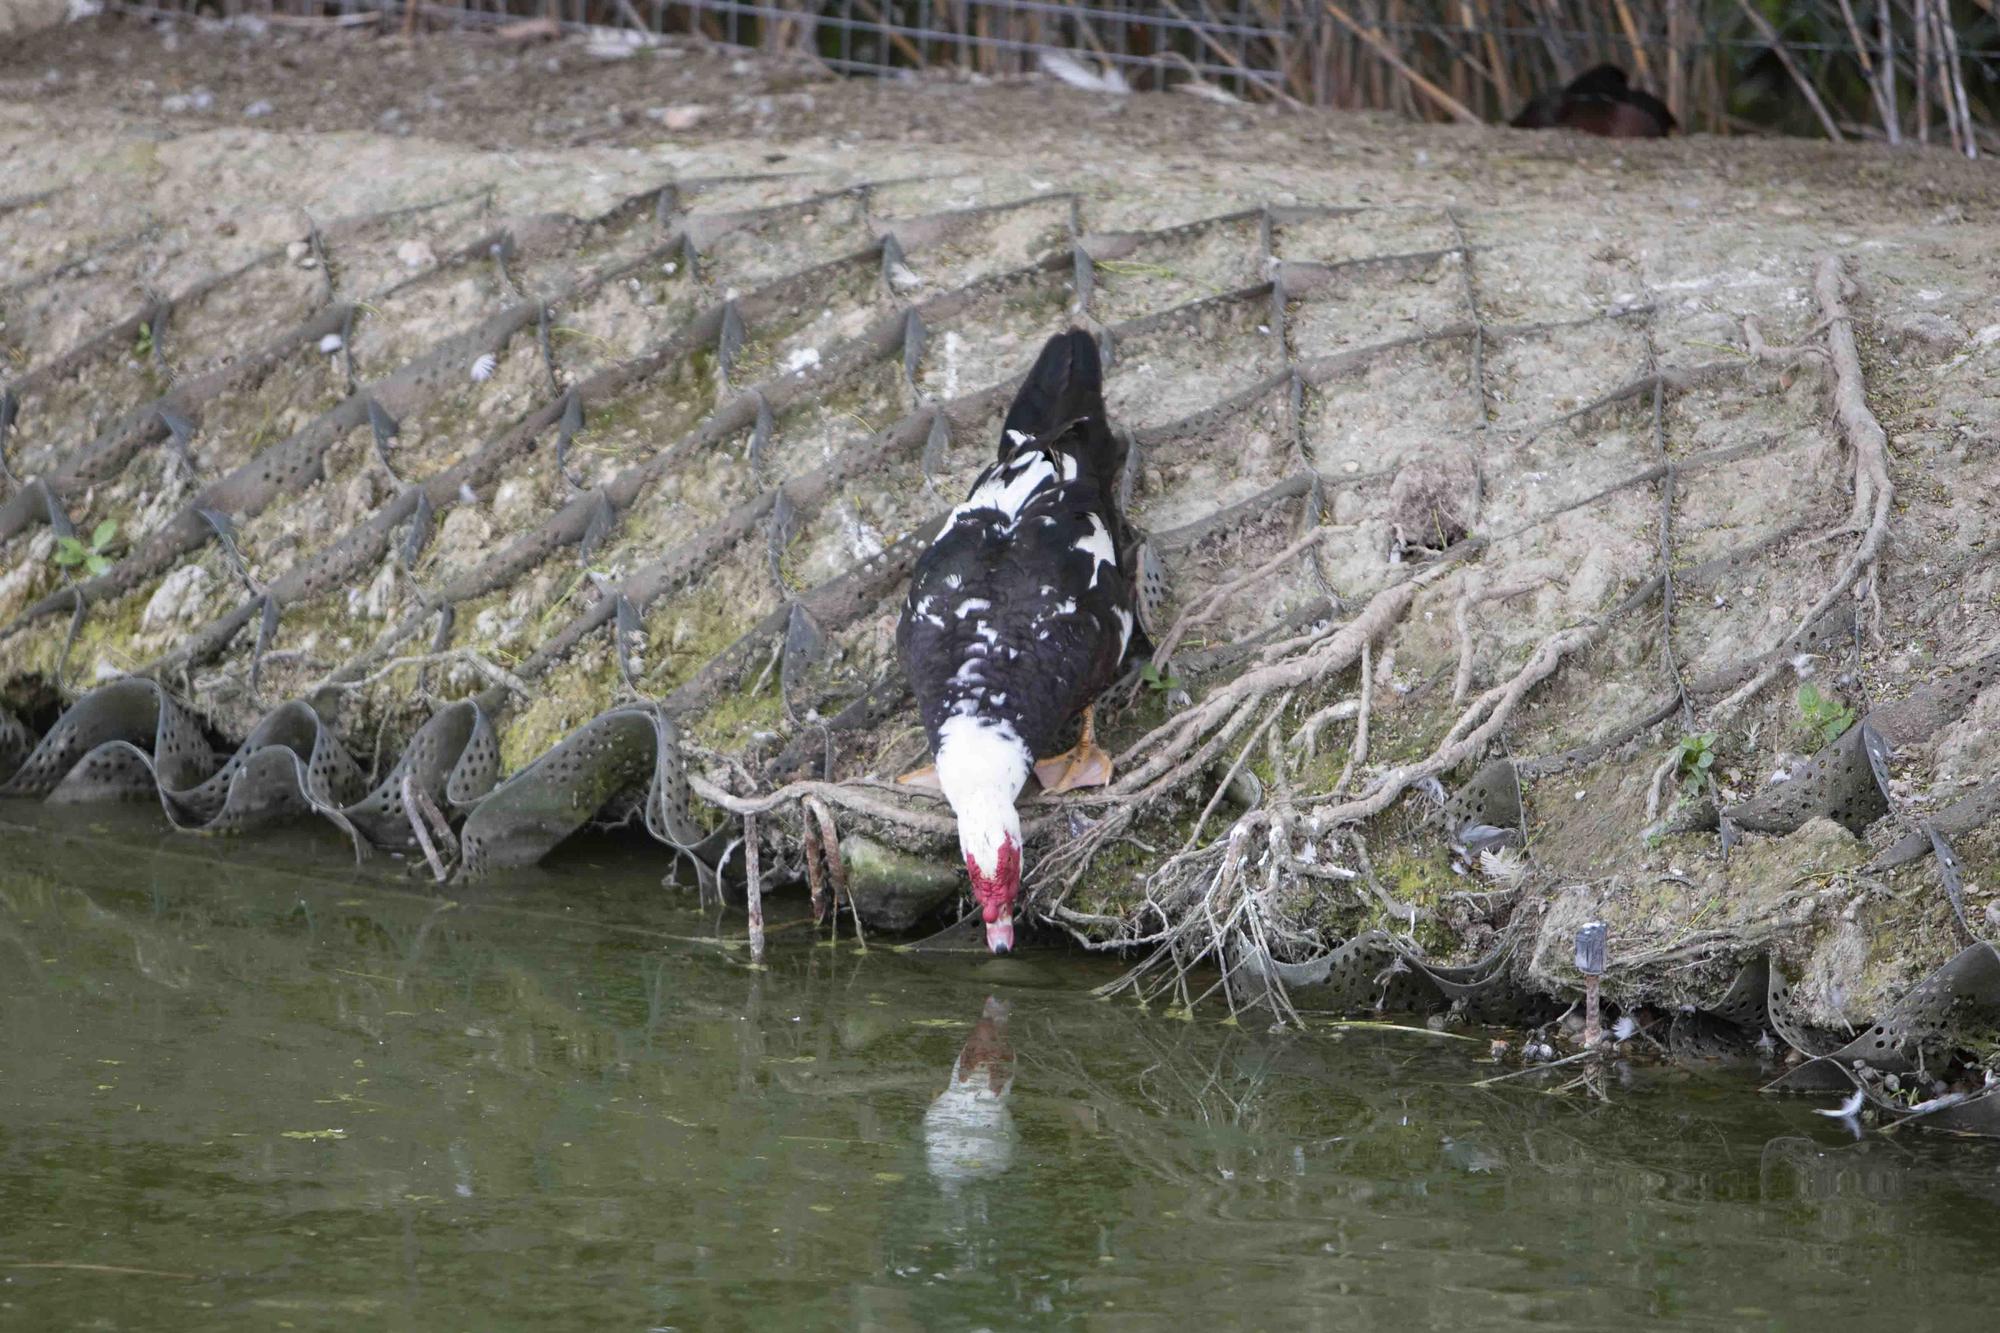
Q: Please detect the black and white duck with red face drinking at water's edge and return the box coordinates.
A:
[896,328,1152,953]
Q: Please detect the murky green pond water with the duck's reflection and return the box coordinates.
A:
[0,809,2000,1329]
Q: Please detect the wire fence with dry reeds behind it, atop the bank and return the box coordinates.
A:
[113,0,2000,156]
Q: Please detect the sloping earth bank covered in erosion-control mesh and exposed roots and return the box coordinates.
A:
[0,20,2000,1129]
